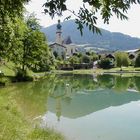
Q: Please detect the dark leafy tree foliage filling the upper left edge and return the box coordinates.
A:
[0,0,29,58]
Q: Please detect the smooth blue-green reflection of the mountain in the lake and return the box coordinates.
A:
[48,90,140,118]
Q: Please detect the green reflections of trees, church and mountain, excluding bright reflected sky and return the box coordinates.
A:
[5,75,140,120]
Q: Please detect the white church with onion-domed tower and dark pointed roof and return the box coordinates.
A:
[49,20,77,59]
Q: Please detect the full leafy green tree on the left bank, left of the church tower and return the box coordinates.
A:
[8,14,53,73]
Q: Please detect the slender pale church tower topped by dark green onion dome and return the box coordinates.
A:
[56,20,62,44]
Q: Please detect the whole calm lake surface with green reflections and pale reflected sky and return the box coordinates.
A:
[2,75,140,140]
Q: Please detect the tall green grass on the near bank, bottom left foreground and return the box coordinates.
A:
[0,87,64,140]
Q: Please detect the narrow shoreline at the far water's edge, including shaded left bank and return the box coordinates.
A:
[0,68,140,87]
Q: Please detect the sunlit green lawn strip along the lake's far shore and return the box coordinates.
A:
[0,62,140,82]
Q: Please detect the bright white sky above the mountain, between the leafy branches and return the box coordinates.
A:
[25,0,140,38]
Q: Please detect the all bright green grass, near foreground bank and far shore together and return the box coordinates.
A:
[0,63,140,140]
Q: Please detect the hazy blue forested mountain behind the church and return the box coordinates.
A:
[41,20,140,50]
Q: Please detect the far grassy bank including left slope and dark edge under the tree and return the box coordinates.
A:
[0,63,140,86]
